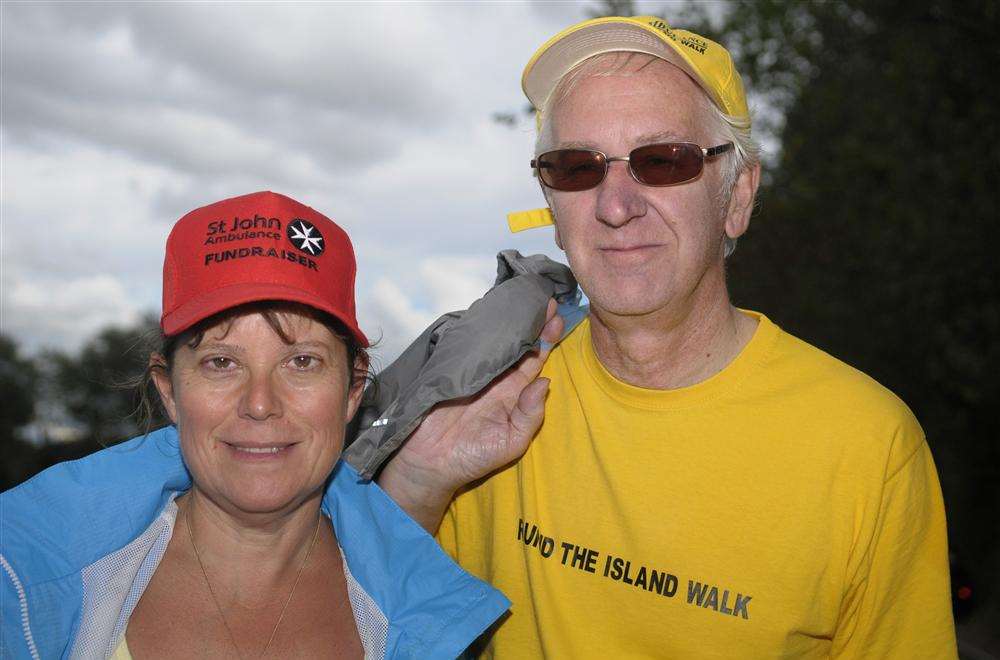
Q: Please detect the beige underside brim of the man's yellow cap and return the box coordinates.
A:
[521,17,704,109]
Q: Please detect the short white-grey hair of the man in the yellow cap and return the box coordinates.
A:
[535,52,760,257]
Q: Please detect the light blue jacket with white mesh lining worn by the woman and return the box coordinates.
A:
[0,427,510,659]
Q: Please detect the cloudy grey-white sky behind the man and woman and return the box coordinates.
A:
[0,2,684,366]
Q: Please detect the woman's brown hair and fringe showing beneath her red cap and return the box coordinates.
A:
[135,300,372,435]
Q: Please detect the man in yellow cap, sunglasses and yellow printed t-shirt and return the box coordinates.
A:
[382,17,956,658]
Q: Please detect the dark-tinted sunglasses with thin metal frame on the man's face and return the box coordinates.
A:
[531,142,733,192]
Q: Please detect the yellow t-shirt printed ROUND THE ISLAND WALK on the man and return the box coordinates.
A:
[439,314,956,659]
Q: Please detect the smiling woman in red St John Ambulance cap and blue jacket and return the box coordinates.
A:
[0,192,509,660]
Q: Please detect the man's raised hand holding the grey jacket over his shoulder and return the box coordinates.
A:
[378,300,563,534]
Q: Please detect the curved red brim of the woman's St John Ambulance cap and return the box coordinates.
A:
[161,283,369,348]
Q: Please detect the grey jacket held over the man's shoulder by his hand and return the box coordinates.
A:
[344,250,587,479]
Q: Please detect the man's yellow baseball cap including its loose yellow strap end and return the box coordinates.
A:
[507,16,750,232]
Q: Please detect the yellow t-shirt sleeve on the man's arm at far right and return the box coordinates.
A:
[831,420,958,659]
